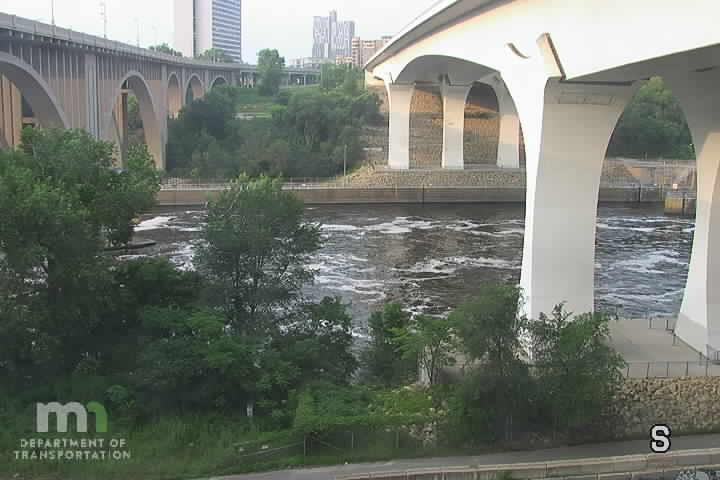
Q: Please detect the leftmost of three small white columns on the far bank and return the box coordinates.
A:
[386,83,415,170]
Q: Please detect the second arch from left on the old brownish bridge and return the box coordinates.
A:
[103,70,165,169]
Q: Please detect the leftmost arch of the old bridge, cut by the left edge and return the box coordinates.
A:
[0,52,70,142]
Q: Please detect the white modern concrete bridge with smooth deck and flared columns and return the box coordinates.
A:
[366,0,720,354]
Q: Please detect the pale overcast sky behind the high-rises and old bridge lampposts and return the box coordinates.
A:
[0,0,435,63]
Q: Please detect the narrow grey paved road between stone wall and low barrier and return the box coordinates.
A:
[212,434,720,480]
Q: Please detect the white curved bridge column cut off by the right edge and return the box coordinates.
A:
[664,69,720,357]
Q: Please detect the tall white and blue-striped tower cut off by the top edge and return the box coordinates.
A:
[175,0,242,62]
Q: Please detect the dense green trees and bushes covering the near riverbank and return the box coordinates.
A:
[0,131,621,479]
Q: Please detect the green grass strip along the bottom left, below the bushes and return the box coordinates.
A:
[0,411,492,480]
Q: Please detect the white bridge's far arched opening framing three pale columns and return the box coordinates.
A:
[378,54,521,169]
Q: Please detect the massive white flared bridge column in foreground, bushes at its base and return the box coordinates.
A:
[508,76,635,318]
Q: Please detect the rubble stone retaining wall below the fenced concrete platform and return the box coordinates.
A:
[616,377,720,437]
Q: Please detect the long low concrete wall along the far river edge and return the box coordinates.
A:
[157,186,663,206]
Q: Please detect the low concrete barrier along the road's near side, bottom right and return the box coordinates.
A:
[335,448,720,480]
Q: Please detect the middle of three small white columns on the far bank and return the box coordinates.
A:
[441,83,472,170]
